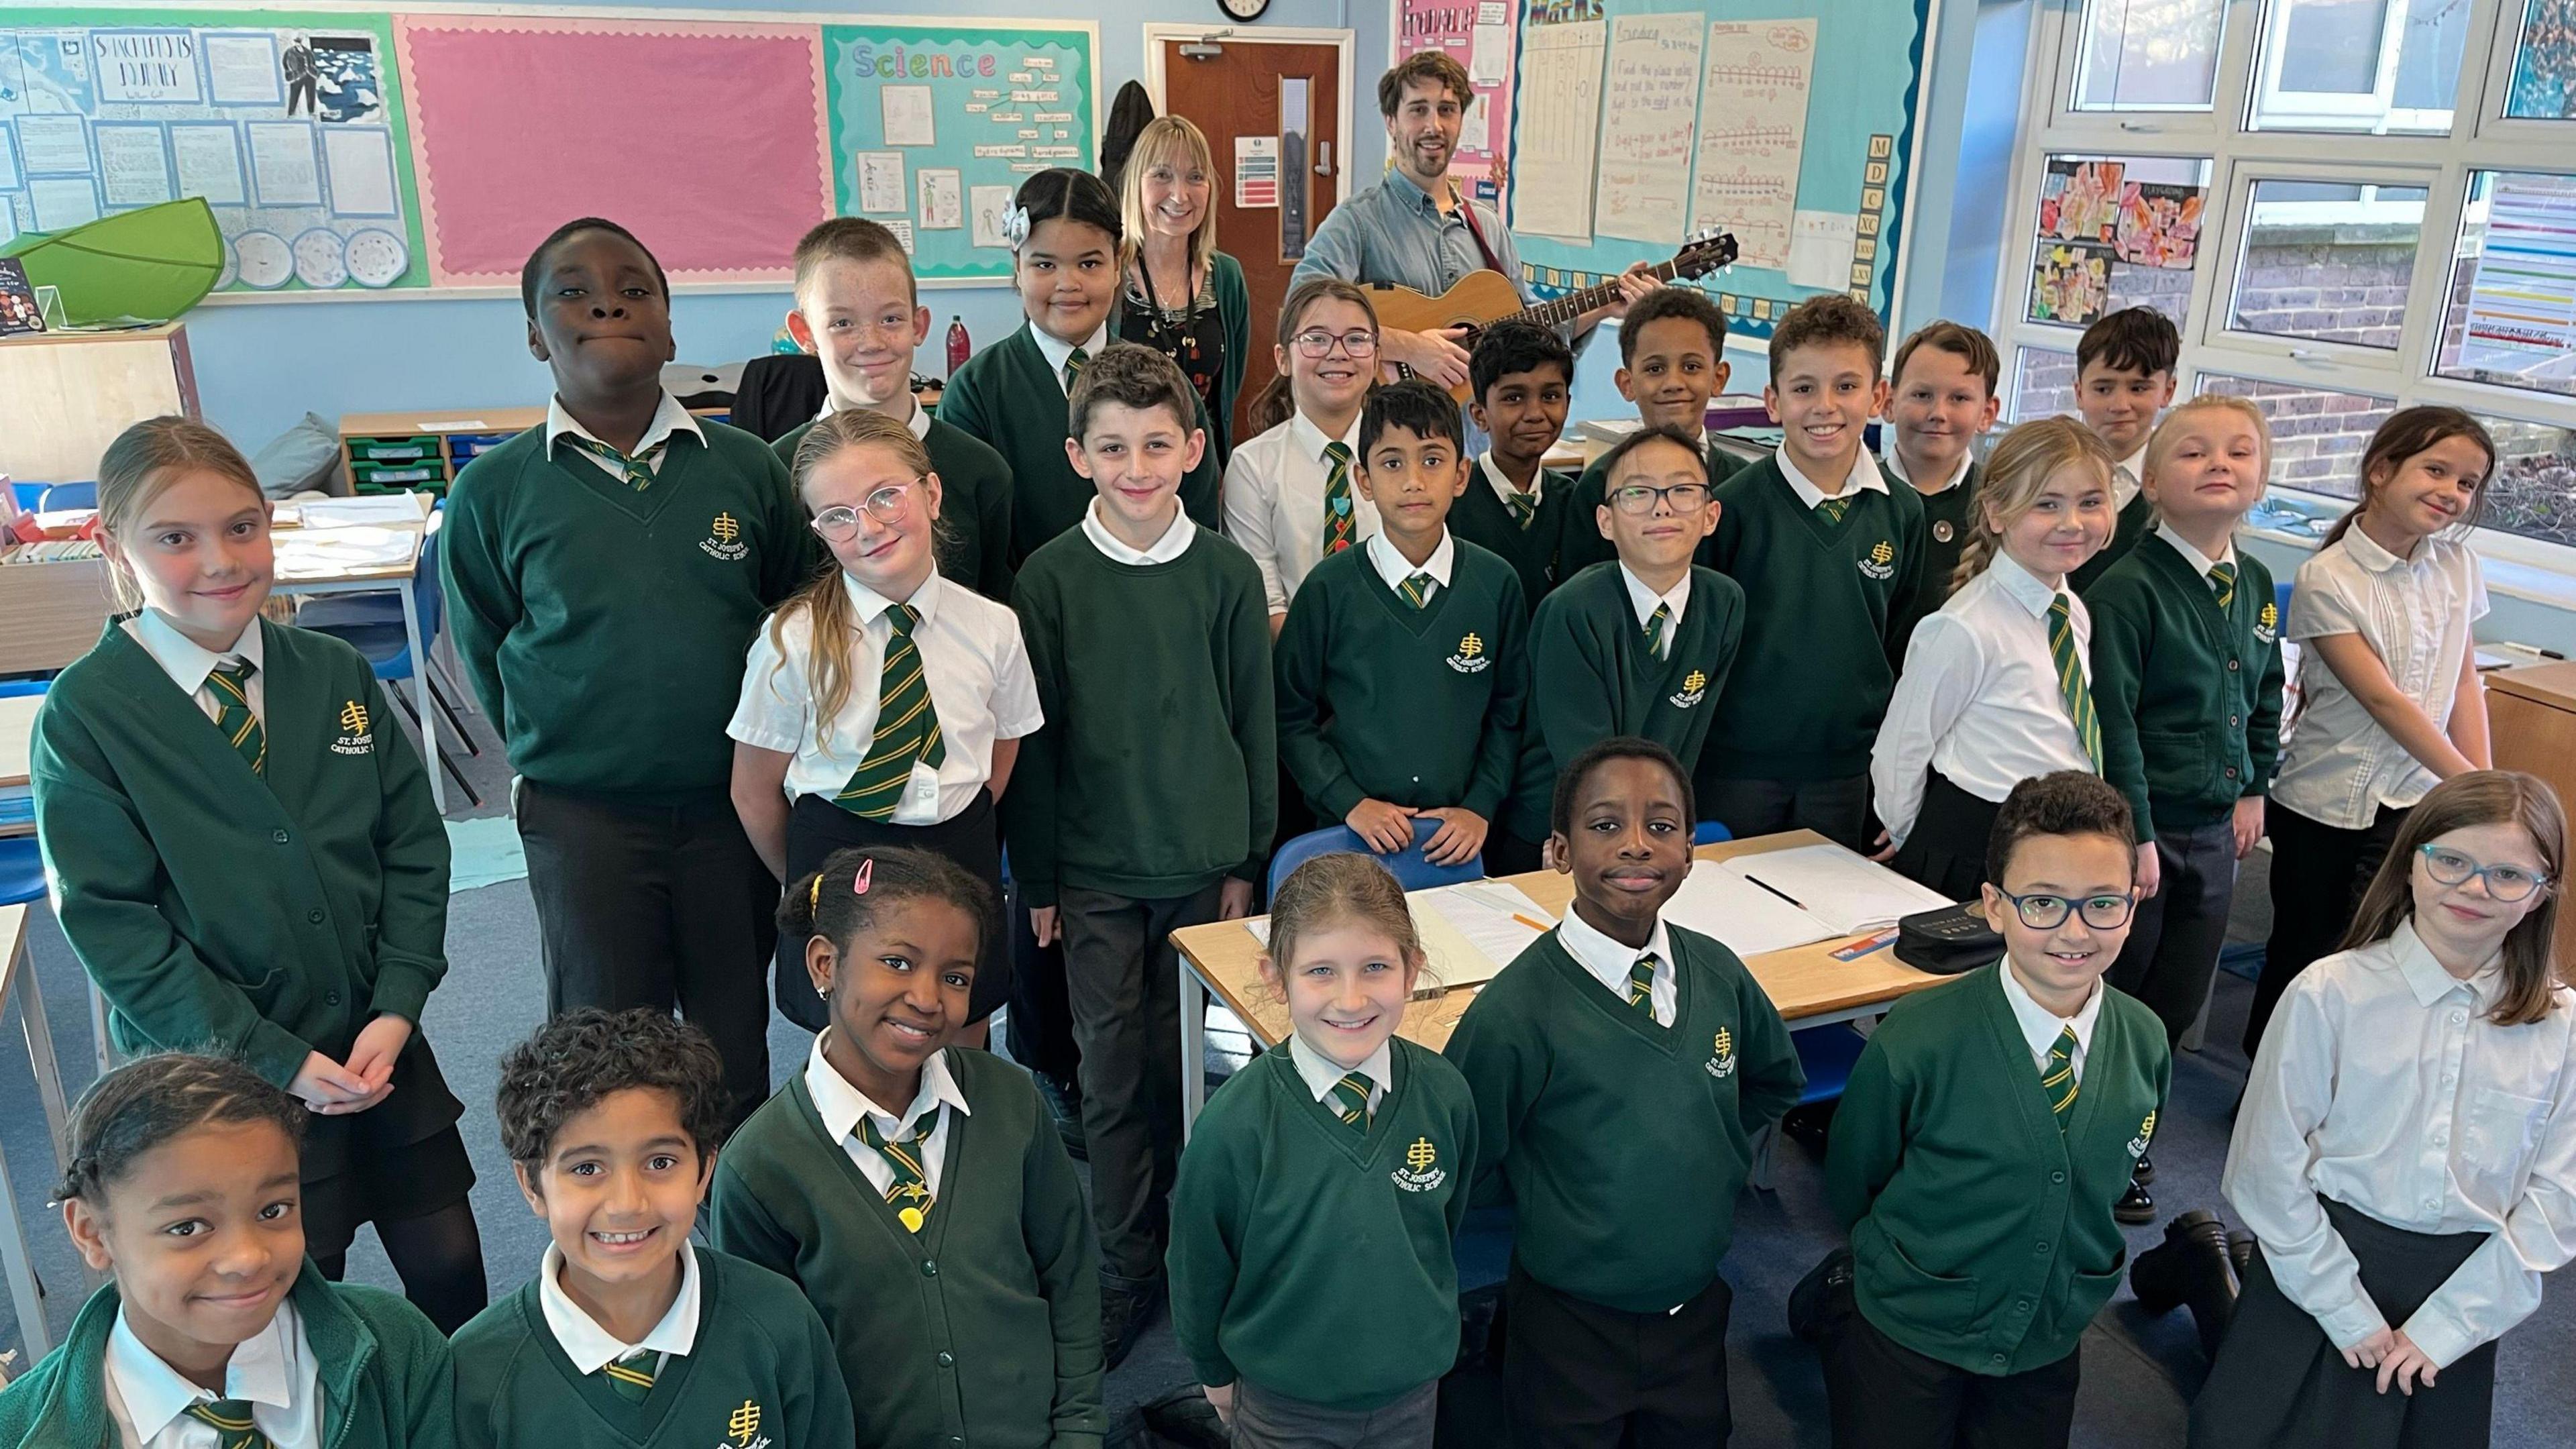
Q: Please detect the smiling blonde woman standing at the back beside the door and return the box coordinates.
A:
[1116,116,1252,467]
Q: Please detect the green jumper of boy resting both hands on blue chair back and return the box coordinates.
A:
[1278,539,1530,822]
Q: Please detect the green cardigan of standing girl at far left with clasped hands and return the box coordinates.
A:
[28,619,448,1085]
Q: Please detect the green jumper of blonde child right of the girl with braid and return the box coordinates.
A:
[2084,534,2282,841]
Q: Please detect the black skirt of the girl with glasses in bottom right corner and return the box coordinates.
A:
[2192,1196,2496,1449]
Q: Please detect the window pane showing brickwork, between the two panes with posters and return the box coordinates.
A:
[2229,180,2424,348]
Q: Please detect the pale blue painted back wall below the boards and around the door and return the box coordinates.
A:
[188,0,1389,449]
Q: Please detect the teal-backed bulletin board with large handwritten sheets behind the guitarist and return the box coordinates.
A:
[1473,0,1940,340]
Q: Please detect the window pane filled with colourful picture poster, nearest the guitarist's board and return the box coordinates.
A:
[2027,155,2210,327]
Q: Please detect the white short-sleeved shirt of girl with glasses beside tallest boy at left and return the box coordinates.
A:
[724,572,1046,825]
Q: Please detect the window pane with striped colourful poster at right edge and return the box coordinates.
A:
[2434,170,2576,397]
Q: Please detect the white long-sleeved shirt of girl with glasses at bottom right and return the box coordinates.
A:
[2218,920,2576,1366]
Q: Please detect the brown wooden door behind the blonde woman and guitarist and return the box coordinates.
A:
[1162,39,1347,443]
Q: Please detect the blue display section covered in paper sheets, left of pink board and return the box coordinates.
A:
[0,8,427,291]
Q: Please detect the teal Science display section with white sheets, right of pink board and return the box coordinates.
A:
[822,25,1095,281]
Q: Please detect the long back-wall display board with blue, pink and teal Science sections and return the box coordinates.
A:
[0,5,1100,299]
